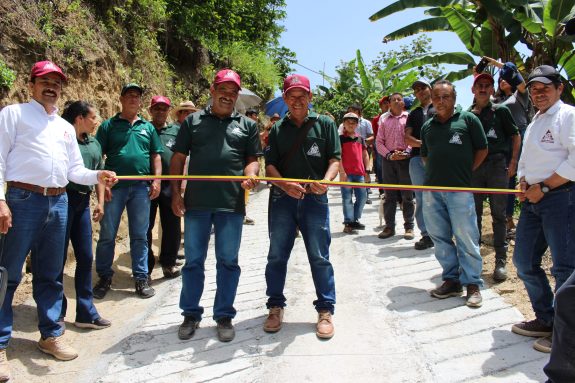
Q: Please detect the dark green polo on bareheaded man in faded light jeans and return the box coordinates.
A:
[421,108,487,187]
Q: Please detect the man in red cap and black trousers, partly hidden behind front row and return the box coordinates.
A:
[148,96,182,278]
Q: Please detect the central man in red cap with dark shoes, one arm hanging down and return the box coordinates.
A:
[170,69,262,342]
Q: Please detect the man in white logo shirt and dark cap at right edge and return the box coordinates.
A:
[512,65,575,356]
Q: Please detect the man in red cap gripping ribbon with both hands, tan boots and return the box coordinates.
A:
[264,74,341,339]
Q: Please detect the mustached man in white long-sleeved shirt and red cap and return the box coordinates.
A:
[0,61,116,381]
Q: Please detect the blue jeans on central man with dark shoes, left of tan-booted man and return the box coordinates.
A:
[180,210,244,321]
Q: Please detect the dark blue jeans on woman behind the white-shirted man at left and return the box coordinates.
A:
[58,190,100,323]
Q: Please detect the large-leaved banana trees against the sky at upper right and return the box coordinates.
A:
[370,0,575,102]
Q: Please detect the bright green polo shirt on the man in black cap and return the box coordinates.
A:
[96,113,164,187]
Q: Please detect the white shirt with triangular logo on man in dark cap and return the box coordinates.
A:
[517,100,575,185]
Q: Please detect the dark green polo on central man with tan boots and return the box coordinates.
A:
[266,112,341,180]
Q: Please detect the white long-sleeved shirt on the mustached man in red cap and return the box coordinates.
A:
[0,100,98,200]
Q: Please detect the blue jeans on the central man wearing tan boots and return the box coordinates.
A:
[266,186,335,314]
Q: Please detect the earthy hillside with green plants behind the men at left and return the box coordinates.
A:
[0,0,292,117]
